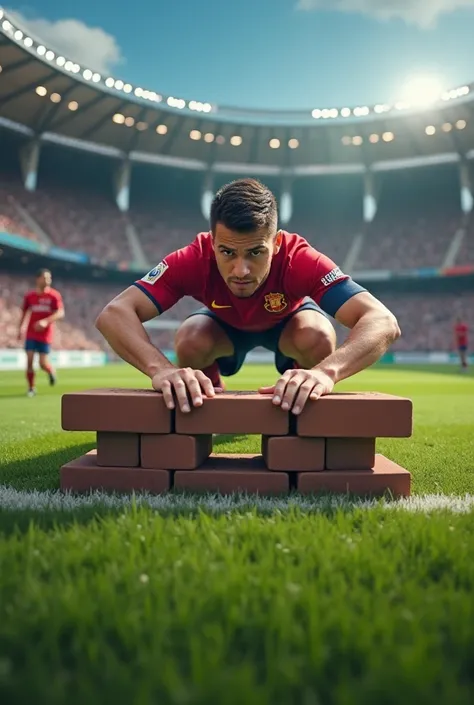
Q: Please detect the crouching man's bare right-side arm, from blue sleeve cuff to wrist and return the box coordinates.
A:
[315,292,401,383]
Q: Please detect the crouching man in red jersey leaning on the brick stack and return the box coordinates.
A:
[95,179,400,414]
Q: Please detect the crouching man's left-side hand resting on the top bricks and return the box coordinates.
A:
[151,367,222,412]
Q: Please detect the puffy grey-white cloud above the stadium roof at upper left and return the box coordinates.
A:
[8,10,124,74]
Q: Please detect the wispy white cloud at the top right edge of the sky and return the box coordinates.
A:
[297,0,474,28]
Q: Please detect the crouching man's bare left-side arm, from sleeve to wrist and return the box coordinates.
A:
[95,286,173,379]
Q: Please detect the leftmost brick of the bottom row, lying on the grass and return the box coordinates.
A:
[60,450,171,494]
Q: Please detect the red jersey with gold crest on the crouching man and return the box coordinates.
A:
[135,231,365,331]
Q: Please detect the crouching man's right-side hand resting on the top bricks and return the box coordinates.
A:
[258,368,334,414]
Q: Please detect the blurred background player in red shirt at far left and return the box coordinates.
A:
[18,269,64,397]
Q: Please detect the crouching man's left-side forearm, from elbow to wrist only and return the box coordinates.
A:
[95,306,173,378]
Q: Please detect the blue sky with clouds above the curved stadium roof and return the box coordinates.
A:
[6,0,474,109]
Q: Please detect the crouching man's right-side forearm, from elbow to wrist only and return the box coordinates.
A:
[316,314,400,383]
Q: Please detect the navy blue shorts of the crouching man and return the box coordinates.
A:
[188,301,328,377]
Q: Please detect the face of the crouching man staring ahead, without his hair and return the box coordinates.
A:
[214,223,281,298]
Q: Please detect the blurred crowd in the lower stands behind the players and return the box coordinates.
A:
[0,273,474,353]
